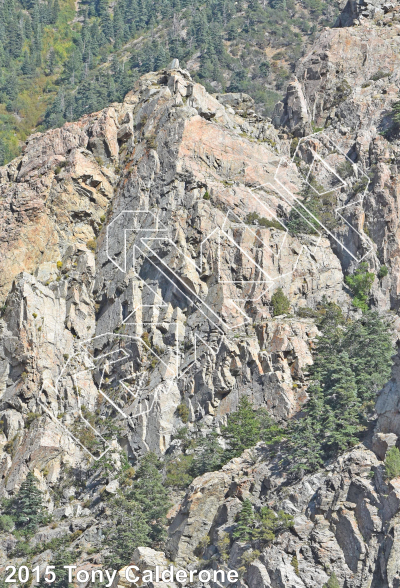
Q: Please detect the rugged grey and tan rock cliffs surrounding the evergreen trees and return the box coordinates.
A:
[0,8,400,588]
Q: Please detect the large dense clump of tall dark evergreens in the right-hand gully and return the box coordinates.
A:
[290,302,392,471]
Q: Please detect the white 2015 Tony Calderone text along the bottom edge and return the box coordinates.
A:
[5,565,239,588]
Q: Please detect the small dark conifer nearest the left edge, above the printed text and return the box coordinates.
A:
[9,472,45,533]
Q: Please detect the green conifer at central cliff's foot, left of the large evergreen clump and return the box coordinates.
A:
[221,396,261,459]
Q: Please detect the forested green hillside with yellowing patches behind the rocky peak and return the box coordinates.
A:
[0,0,338,164]
